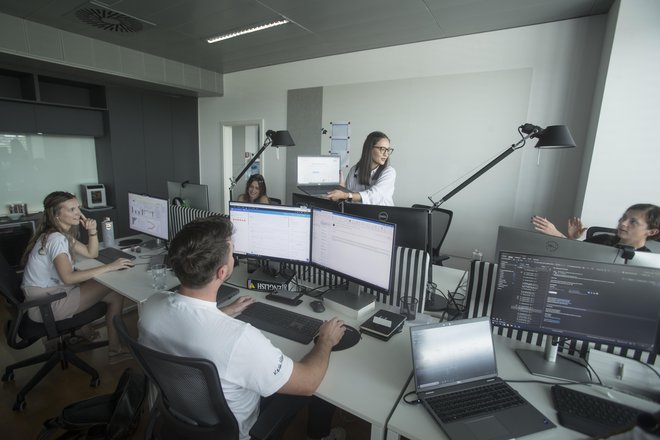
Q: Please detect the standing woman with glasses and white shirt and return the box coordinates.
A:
[327,131,396,206]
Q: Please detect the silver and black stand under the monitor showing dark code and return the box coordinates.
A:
[516,336,591,382]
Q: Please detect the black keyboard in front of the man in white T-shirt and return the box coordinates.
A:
[236,302,323,344]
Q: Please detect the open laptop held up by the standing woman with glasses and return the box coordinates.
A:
[297,156,346,197]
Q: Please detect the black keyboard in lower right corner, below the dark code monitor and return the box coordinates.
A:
[552,385,643,437]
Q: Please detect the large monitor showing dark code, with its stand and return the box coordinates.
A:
[491,251,660,381]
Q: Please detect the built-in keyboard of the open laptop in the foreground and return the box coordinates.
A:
[426,382,525,423]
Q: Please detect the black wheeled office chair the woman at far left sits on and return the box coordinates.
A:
[0,254,108,411]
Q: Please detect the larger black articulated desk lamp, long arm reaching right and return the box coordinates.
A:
[425,123,575,313]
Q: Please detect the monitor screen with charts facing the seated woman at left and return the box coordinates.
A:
[128,193,169,240]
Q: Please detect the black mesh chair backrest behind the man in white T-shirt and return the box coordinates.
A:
[113,317,239,439]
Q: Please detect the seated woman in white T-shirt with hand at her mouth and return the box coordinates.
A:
[22,191,133,364]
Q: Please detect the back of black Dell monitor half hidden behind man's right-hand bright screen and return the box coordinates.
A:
[344,203,433,254]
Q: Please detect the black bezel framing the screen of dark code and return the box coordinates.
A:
[490,251,660,354]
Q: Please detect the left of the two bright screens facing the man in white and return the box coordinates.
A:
[229,202,312,263]
